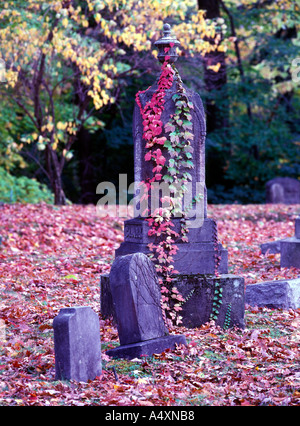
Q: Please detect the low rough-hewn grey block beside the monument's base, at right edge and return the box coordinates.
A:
[245,278,300,309]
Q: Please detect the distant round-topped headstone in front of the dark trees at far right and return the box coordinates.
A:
[266,177,300,204]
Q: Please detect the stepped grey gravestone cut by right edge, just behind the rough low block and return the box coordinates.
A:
[260,216,300,268]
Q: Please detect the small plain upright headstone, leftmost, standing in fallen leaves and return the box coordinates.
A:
[53,306,102,382]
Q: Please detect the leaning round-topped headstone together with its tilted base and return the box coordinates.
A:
[107,253,186,359]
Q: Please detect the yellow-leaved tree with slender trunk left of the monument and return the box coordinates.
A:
[0,0,224,204]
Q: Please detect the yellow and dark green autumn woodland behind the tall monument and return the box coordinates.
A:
[0,0,300,204]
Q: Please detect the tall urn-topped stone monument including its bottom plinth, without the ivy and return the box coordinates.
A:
[101,24,244,328]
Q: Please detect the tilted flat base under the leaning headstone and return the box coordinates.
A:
[106,334,187,359]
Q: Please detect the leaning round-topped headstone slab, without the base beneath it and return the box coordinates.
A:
[110,253,167,345]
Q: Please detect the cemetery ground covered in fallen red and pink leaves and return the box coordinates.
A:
[0,204,300,406]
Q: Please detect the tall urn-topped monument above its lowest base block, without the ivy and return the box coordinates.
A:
[116,24,228,274]
